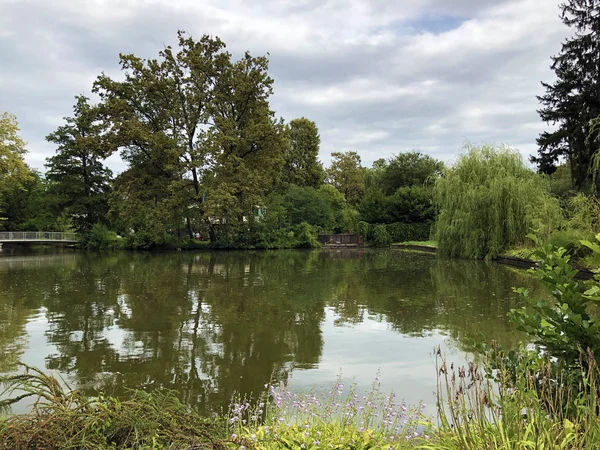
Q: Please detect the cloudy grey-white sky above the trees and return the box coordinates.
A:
[0,0,569,171]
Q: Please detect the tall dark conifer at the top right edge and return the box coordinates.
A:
[532,0,600,190]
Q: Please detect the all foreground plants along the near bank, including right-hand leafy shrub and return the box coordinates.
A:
[0,235,600,450]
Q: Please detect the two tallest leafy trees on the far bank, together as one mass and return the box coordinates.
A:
[94,32,283,240]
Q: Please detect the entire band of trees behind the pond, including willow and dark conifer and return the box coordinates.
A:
[0,0,600,258]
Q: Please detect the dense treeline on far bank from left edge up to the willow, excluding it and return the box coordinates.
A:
[0,32,442,248]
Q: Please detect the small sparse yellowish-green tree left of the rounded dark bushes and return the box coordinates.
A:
[327,152,365,206]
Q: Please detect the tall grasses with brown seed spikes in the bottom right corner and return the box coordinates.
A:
[434,345,600,450]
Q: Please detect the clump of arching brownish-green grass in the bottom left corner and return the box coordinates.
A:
[0,368,226,450]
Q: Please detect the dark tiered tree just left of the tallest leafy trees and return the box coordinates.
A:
[46,96,112,232]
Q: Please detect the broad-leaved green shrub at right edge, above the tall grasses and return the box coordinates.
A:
[510,238,600,369]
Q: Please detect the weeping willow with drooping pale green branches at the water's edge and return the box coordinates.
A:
[434,145,562,258]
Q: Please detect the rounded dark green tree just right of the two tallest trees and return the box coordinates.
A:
[283,117,325,188]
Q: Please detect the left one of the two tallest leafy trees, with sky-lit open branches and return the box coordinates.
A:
[94,32,230,241]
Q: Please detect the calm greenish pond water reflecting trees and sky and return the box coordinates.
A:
[0,250,536,412]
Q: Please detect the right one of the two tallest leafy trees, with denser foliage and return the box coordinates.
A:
[204,53,285,240]
